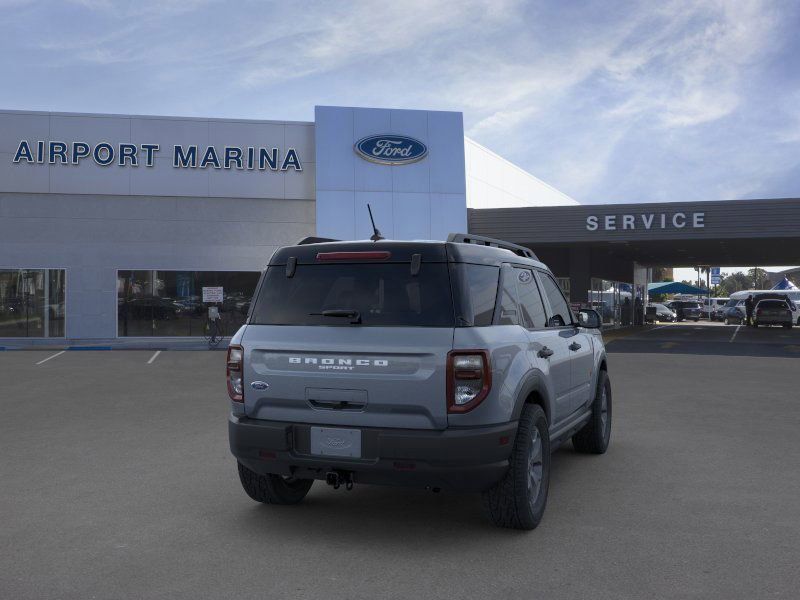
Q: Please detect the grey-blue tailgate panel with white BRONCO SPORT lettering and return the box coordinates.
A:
[242,325,453,429]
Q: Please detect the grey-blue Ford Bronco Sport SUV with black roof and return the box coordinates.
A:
[227,234,611,529]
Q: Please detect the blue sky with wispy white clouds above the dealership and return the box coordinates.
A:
[0,0,800,204]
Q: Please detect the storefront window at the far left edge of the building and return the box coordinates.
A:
[0,269,66,337]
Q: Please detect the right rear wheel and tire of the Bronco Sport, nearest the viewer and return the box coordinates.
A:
[483,404,550,529]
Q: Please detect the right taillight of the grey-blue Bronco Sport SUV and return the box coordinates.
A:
[447,350,492,413]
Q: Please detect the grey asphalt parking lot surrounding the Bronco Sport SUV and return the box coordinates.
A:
[0,324,800,600]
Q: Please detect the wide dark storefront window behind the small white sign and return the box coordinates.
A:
[117,271,260,337]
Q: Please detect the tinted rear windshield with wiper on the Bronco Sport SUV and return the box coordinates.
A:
[251,263,454,327]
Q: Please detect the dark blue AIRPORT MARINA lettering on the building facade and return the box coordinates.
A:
[14,140,303,171]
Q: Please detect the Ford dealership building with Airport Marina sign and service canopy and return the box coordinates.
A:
[0,106,800,346]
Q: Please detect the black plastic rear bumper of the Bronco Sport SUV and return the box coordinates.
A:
[228,415,517,492]
